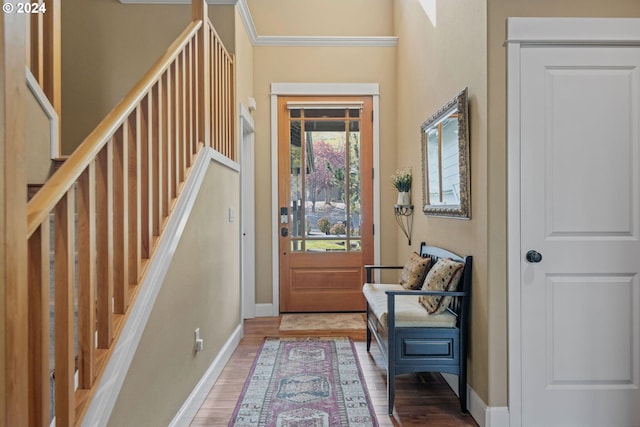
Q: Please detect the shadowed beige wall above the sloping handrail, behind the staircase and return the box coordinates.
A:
[62,0,191,154]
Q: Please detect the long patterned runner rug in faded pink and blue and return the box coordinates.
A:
[229,337,378,427]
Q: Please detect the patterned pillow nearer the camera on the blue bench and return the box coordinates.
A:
[419,258,464,314]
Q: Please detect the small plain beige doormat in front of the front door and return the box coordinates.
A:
[280,313,366,331]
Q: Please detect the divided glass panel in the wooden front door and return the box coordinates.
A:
[289,109,361,252]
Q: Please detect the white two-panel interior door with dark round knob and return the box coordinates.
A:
[516,40,640,427]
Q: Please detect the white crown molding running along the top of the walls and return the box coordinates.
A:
[119,0,398,47]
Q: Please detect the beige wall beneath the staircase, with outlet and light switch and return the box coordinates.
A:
[109,162,240,426]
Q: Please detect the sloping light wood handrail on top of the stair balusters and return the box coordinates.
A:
[27,21,202,237]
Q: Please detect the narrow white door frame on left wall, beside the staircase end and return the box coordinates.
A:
[238,103,256,319]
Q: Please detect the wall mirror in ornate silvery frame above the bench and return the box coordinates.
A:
[421,88,471,218]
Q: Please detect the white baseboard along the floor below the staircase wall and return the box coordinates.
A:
[169,323,244,427]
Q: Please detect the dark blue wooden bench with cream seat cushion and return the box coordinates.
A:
[363,242,472,415]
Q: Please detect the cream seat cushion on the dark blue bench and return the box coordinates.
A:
[362,283,456,328]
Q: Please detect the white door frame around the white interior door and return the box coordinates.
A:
[505,18,640,427]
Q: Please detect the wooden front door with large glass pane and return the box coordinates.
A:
[276,97,373,312]
